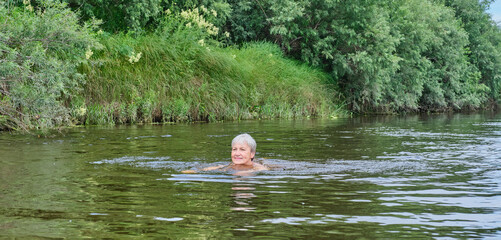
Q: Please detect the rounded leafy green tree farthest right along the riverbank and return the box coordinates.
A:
[387,1,487,111]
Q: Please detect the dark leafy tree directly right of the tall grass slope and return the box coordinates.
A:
[242,0,398,111]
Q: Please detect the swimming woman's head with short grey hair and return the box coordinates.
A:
[231,133,257,165]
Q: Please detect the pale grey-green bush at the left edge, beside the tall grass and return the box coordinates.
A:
[0,1,99,129]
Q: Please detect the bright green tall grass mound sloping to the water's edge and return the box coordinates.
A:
[79,31,341,124]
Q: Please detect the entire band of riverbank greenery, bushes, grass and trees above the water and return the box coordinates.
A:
[0,0,501,131]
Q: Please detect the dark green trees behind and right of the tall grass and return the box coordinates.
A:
[55,0,501,112]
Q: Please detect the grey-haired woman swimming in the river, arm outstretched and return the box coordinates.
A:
[182,133,269,173]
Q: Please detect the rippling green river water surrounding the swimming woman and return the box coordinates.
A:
[0,113,501,239]
